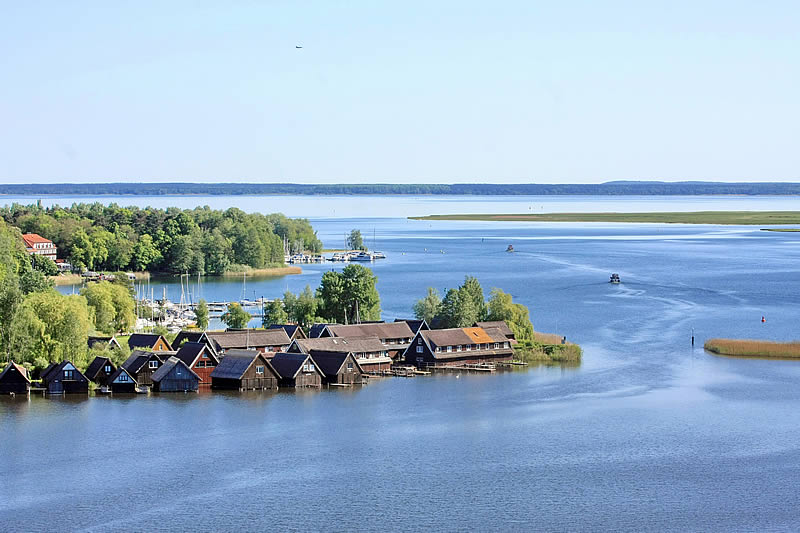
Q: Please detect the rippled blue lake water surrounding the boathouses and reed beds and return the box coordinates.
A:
[0,198,800,531]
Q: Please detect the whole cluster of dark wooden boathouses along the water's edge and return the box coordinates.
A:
[0,320,516,394]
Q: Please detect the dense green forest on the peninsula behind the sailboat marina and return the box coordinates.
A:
[0,203,322,274]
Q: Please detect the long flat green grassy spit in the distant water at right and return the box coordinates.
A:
[409,211,800,226]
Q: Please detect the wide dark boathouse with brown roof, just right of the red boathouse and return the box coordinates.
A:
[211,350,280,390]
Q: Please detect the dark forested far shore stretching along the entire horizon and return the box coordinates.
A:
[0,181,800,196]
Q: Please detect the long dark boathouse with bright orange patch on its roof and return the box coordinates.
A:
[404,328,514,367]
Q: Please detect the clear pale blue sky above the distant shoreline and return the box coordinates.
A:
[0,0,800,183]
